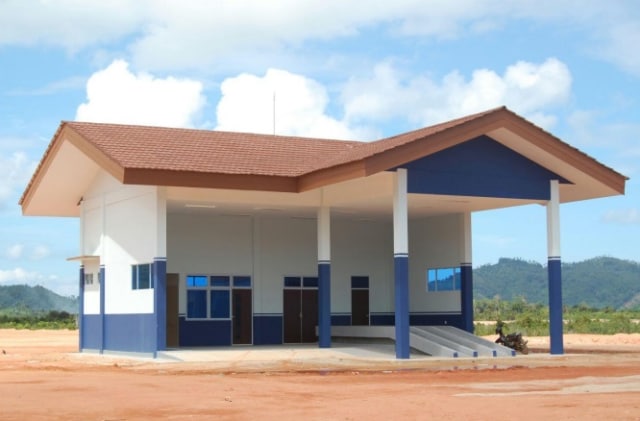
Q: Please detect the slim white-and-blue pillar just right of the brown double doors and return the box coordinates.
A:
[318,206,331,348]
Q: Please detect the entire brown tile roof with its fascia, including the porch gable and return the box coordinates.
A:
[20,107,627,204]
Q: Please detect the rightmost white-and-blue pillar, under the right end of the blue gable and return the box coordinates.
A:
[547,180,564,354]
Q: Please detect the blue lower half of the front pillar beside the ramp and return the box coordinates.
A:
[394,254,410,359]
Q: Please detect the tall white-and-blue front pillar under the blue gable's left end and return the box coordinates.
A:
[393,168,410,359]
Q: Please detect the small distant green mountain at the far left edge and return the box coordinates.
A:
[0,285,78,314]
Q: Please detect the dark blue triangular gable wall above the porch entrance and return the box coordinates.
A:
[403,136,566,200]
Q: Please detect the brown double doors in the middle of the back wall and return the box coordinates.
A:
[283,277,318,344]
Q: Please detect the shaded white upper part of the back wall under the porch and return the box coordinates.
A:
[167,214,461,313]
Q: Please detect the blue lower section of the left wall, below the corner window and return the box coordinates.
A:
[104,313,157,353]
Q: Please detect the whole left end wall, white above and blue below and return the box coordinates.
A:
[81,172,166,352]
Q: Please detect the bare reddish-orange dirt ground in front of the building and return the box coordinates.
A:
[0,330,640,421]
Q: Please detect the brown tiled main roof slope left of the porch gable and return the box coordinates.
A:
[63,122,361,177]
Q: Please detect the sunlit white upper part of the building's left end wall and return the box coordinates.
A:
[81,172,166,314]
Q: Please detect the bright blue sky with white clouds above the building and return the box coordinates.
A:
[0,0,640,294]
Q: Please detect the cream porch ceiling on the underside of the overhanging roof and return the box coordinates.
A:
[167,172,543,220]
